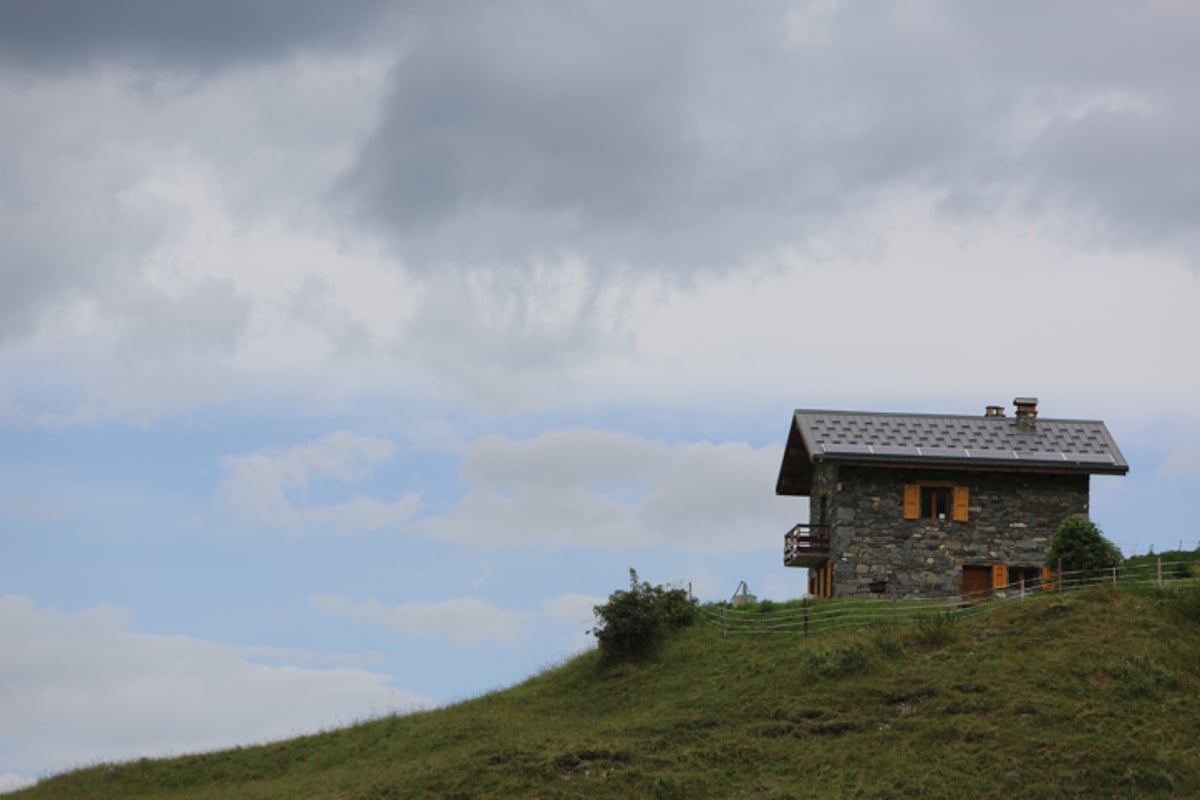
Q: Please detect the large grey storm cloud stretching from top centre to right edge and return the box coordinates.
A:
[336,2,1200,273]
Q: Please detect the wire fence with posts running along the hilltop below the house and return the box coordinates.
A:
[700,559,1200,636]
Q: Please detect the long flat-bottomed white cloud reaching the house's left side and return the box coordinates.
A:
[421,428,802,551]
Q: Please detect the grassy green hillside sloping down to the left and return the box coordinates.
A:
[12,588,1200,800]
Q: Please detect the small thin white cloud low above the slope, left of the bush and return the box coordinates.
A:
[308,595,526,648]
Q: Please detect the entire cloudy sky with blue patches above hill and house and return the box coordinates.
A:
[0,0,1200,787]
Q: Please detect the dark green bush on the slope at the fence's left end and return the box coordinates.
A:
[592,570,700,663]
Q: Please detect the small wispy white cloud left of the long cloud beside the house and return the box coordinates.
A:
[217,432,421,533]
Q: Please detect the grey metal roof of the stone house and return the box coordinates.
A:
[775,409,1129,494]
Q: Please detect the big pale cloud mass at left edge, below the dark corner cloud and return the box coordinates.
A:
[0,50,396,428]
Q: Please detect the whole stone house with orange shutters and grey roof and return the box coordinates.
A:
[775,397,1129,600]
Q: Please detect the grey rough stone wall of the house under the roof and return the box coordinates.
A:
[809,464,1088,597]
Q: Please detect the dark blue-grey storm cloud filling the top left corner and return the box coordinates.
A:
[0,0,384,72]
